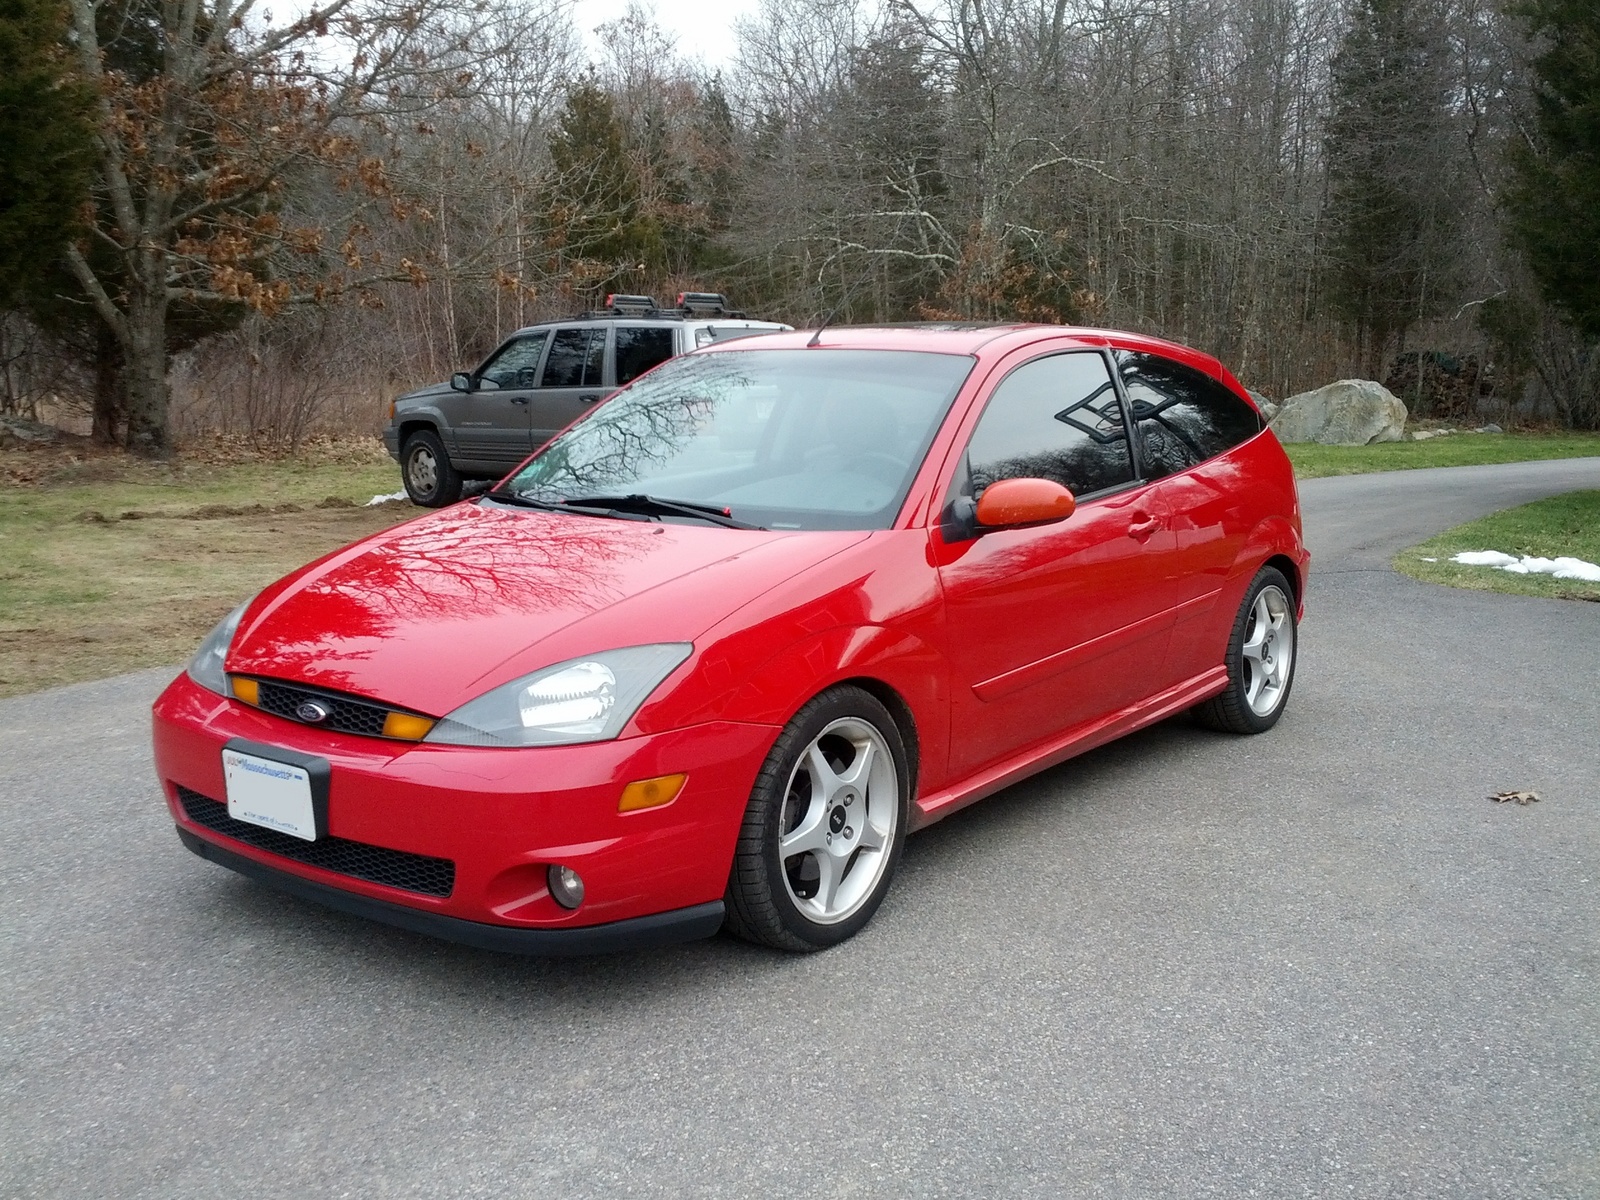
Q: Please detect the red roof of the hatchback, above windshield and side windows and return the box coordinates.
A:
[699,322,1229,378]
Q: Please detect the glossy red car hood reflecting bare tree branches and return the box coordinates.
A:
[227,504,869,717]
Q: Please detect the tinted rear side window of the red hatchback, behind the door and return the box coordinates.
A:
[1117,350,1261,478]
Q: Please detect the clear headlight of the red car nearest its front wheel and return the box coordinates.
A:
[422,642,694,746]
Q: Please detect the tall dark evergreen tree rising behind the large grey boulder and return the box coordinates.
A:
[1326,0,1464,376]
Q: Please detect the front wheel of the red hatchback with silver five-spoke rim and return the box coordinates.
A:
[725,685,910,952]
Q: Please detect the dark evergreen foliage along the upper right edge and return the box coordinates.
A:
[1507,0,1600,339]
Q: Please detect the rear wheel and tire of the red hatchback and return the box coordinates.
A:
[1194,566,1299,733]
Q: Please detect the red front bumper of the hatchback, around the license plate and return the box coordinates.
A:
[154,675,778,954]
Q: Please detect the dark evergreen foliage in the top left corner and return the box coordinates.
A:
[0,0,93,304]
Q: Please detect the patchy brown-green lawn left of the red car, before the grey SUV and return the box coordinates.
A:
[0,442,418,696]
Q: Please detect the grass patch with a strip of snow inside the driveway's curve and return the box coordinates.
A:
[1394,491,1600,600]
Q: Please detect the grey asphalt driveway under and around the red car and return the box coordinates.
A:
[0,459,1600,1200]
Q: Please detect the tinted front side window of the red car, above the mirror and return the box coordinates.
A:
[966,354,1133,499]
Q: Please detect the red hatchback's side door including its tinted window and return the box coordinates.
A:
[933,350,1171,776]
